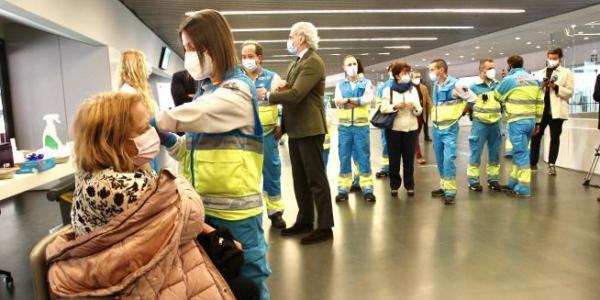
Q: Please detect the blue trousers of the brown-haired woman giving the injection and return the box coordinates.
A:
[206,215,271,300]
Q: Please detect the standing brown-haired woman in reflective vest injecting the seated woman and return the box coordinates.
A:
[156,9,271,299]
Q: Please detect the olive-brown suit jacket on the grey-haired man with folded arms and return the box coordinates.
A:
[269,49,327,138]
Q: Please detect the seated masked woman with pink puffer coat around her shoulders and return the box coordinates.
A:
[46,93,234,299]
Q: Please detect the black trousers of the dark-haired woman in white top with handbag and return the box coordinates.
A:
[385,129,419,190]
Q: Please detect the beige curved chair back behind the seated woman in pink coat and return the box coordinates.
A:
[29,226,69,300]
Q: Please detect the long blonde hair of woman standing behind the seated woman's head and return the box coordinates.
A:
[119,50,156,112]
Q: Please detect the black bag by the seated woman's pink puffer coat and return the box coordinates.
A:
[196,228,244,280]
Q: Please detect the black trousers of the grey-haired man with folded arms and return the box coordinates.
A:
[289,134,333,229]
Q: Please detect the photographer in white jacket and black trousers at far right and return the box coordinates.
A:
[530,48,573,176]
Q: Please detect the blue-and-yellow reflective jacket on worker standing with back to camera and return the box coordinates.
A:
[495,69,544,122]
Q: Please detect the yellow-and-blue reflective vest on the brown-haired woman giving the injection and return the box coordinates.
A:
[181,68,263,221]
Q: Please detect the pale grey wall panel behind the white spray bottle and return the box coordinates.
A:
[5,24,111,149]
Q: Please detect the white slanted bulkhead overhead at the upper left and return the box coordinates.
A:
[0,0,183,83]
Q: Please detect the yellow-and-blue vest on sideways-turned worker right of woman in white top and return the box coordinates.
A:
[431,76,467,129]
